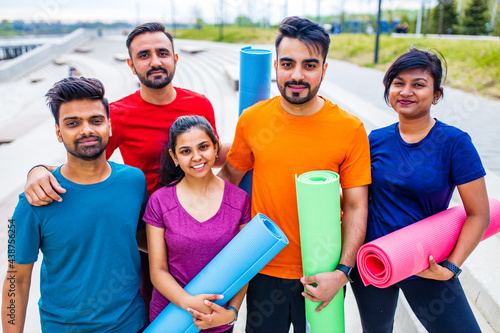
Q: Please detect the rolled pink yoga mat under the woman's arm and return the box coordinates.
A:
[357,198,500,288]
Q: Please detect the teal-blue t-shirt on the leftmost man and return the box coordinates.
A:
[13,162,147,333]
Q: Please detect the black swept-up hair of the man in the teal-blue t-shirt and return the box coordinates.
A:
[45,77,109,125]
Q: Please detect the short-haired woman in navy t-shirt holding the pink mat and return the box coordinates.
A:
[352,48,489,332]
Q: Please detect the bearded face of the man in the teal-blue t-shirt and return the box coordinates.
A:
[56,99,111,161]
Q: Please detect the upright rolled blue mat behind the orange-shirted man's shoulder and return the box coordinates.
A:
[238,46,272,198]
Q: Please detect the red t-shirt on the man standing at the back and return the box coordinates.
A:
[106,87,217,195]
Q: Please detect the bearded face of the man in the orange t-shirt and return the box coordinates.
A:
[275,37,327,105]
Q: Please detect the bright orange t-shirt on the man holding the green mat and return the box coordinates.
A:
[227,96,371,279]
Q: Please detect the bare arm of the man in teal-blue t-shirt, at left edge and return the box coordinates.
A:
[2,262,33,333]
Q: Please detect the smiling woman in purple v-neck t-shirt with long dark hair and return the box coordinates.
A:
[144,116,250,332]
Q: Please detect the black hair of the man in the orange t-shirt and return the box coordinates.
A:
[275,16,330,63]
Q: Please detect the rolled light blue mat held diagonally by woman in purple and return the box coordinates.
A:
[144,213,288,333]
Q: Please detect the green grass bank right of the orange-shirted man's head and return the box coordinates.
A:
[329,34,500,100]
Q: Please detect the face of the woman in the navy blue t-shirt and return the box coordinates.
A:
[389,68,442,119]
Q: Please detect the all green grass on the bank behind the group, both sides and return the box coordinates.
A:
[176,25,500,100]
